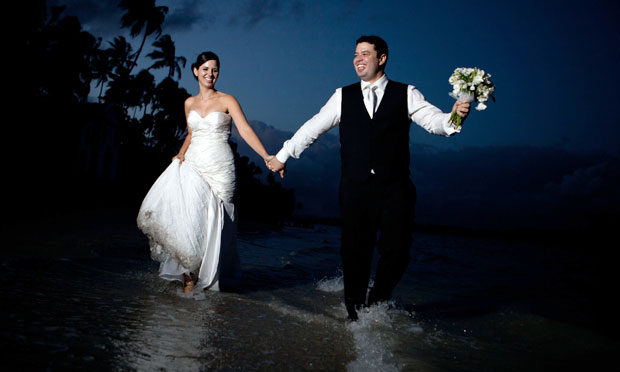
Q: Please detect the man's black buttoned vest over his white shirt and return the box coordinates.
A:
[339,80,411,183]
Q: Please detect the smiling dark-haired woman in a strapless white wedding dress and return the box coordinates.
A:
[137,52,271,293]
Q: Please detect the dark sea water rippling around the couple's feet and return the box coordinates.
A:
[0,211,618,371]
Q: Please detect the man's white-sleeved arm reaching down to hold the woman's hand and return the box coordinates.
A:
[268,88,342,172]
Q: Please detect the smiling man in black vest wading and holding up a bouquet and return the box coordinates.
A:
[267,36,469,320]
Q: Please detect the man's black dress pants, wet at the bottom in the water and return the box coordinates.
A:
[340,176,416,313]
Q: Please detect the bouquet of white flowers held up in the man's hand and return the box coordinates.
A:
[448,67,495,128]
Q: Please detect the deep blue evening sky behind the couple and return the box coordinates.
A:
[51,0,620,230]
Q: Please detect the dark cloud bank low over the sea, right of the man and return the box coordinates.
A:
[412,146,620,229]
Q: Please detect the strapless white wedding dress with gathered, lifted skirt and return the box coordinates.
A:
[137,110,241,291]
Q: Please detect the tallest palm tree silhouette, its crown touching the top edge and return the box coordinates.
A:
[118,0,168,73]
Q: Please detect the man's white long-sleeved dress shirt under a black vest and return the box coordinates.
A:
[276,75,461,163]
